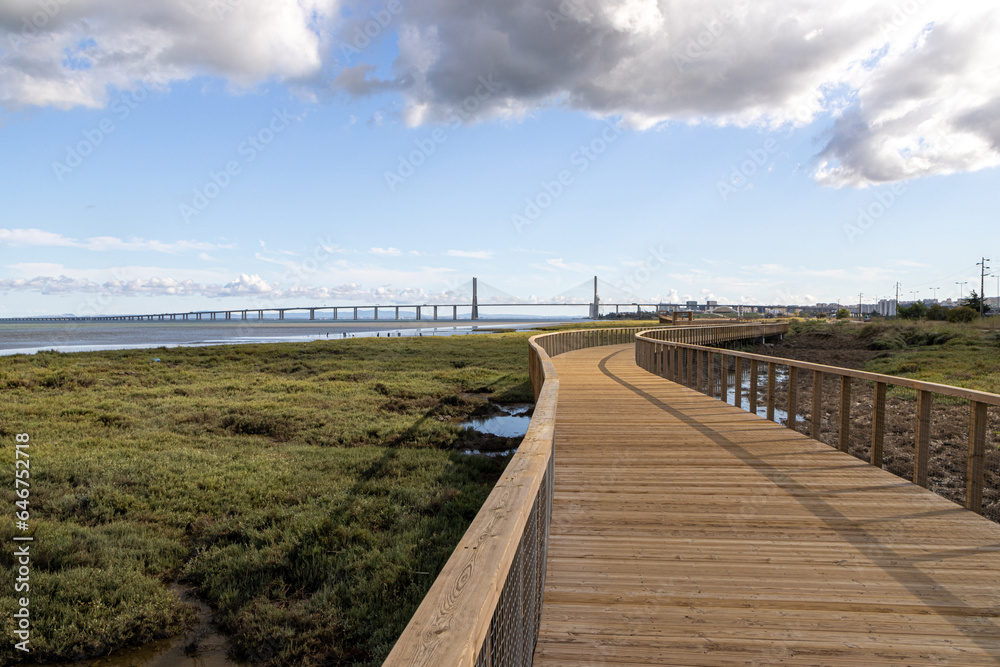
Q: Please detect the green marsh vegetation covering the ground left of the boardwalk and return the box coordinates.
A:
[0,333,531,665]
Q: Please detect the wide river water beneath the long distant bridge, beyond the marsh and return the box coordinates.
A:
[0,320,554,355]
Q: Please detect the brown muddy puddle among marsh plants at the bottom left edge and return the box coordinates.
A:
[43,584,252,667]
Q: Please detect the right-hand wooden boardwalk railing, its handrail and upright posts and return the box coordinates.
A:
[636,329,1000,518]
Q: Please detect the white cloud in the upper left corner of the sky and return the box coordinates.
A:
[0,0,339,109]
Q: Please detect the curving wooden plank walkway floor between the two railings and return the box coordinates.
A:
[534,345,1000,667]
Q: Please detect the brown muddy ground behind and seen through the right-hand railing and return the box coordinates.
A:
[750,330,1000,521]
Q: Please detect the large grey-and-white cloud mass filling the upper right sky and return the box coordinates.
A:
[342,0,1000,187]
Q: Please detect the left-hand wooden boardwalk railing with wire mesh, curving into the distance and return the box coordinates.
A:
[384,325,772,667]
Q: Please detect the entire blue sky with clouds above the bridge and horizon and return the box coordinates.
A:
[0,0,1000,317]
